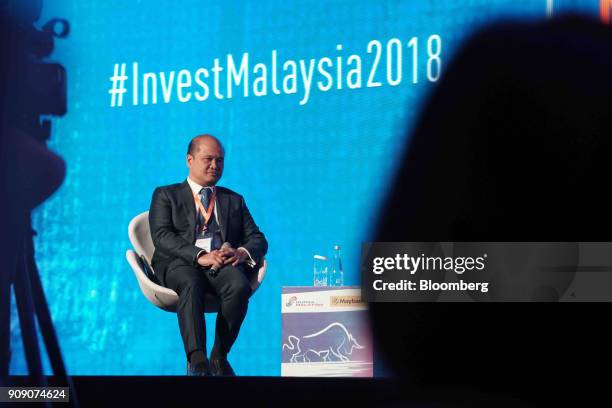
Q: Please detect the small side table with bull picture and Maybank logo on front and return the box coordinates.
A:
[281,286,373,377]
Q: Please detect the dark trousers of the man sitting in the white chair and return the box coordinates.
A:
[165,265,251,358]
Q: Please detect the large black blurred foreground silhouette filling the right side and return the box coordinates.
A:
[371,17,612,406]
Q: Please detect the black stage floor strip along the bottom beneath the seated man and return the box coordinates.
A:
[0,376,532,408]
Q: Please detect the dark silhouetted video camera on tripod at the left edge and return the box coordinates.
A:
[0,0,73,398]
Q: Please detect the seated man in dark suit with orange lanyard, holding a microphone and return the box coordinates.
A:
[149,135,268,375]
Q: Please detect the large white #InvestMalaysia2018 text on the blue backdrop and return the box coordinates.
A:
[108,34,442,108]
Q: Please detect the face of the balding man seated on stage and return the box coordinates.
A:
[187,138,224,186]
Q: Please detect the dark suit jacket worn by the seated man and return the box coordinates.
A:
[149,180,268,284]
